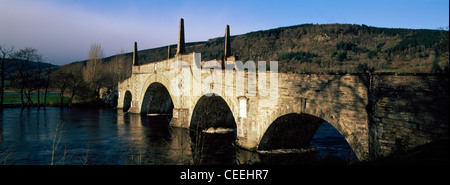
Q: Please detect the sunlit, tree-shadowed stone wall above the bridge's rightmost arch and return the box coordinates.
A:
[269,73,369,160]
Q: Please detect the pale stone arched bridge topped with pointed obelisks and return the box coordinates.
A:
[118,20,449,160]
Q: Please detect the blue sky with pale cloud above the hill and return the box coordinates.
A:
[0,0,449,65]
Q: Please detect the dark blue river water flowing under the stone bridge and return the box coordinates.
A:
[0,107,357,165]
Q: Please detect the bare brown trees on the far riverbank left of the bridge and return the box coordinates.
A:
[0,44,132,107]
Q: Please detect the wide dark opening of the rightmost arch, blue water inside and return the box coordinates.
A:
[258,113,358,164]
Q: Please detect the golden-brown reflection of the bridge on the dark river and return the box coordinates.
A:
[117,110,258,165]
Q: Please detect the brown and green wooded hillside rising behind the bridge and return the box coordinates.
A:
[105,24,449,73]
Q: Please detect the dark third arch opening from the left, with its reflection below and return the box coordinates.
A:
[189,94,237,164]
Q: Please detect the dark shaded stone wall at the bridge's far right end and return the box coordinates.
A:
[370,74,449,158]
